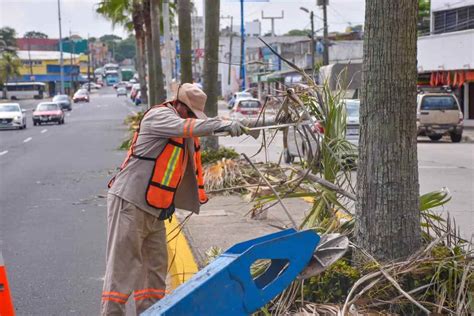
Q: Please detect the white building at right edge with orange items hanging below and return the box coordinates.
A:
[418,0,474,120]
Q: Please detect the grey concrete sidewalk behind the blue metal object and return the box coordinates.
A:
[177,194,311,268]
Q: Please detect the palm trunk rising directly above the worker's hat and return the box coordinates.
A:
[178,0,193,83]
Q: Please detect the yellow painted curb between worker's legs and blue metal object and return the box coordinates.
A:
[165,215,199,291]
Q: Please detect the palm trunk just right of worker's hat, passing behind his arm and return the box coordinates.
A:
[203,0,220,150]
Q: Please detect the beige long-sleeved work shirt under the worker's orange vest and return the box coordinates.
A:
[109,105,230,216]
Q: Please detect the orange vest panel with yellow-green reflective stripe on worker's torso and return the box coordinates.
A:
[146,138,184,209]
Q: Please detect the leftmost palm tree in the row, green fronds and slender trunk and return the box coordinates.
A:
[96,0,148,104]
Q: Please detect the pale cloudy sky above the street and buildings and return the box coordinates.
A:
[0,0,365,38]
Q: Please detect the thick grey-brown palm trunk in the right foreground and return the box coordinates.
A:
[355,0,421,261]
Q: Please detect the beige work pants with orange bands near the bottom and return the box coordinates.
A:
[101,194,168,315]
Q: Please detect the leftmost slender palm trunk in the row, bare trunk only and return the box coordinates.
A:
[132,0,148,104]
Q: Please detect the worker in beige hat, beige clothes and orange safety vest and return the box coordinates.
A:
[101,83,244,315]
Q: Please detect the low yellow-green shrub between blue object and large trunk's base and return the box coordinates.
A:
[304,259,361,303]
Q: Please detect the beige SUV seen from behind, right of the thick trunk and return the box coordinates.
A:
[416,93,464,143]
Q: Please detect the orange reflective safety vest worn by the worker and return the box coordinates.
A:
[109,105,209,209]
